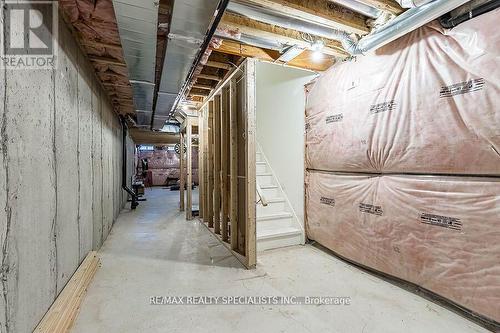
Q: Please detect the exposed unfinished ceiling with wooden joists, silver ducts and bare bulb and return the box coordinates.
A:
[59,0,476,141]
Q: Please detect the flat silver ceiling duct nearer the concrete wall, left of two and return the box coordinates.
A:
[113,0,158,125]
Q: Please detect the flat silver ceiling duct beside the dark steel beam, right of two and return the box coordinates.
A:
[152,0,219,130]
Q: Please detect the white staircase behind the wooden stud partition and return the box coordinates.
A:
[256,145,304,251]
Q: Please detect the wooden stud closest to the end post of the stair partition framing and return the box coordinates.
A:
[229,78,238,250]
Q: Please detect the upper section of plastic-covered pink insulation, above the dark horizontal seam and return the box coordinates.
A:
[306,10,500,175]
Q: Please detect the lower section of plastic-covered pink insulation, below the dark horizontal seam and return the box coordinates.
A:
[306,172,500,322]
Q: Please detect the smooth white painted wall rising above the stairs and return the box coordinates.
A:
[256,62,316,224]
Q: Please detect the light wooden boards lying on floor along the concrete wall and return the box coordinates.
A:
[34,251,99,333]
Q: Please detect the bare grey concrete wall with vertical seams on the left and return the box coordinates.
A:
[0,16,132,333]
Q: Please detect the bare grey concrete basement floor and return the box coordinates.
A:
[73,188,486,333]
